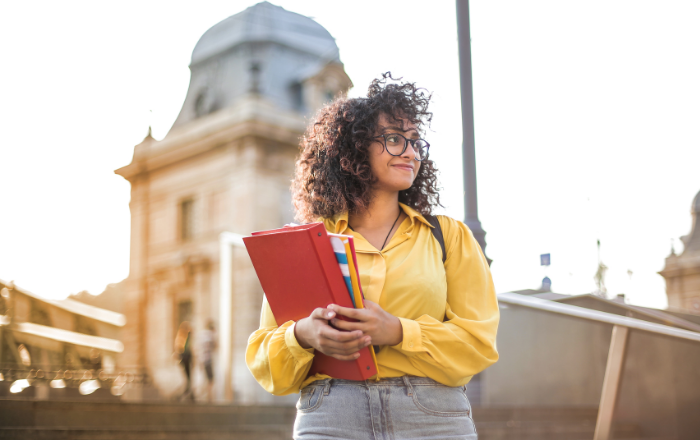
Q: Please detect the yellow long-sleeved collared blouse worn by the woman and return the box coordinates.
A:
[246,204,499,395]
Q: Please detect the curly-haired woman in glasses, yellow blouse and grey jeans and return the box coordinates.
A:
[246,74,499,440]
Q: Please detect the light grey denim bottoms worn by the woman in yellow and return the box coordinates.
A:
[294,376,477,440]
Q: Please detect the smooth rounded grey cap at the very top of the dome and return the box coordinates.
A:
[192,1,339,65]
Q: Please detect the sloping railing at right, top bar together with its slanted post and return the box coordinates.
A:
[498,293,700,440]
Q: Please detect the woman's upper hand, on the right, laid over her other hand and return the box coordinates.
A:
[328,300,403,345]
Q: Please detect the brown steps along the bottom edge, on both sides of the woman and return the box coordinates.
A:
[0,399,642,440]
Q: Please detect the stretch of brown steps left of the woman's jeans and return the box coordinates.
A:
[0,399,296,440]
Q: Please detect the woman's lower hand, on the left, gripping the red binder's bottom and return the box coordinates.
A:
[294,308,372,361]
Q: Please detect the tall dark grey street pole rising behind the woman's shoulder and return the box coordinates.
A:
[457,0,491,264]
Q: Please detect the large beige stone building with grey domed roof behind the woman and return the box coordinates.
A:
[116,2,352,403]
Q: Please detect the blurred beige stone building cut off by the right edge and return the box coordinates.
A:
[659,192,700,313]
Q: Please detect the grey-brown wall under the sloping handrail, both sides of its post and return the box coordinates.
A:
[481,305,700,440]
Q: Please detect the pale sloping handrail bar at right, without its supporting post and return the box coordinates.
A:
[498,292,700,342]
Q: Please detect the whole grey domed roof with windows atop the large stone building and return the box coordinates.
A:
[173,2,352,132]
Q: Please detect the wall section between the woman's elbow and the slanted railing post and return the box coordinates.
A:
[481,304,612,406]
